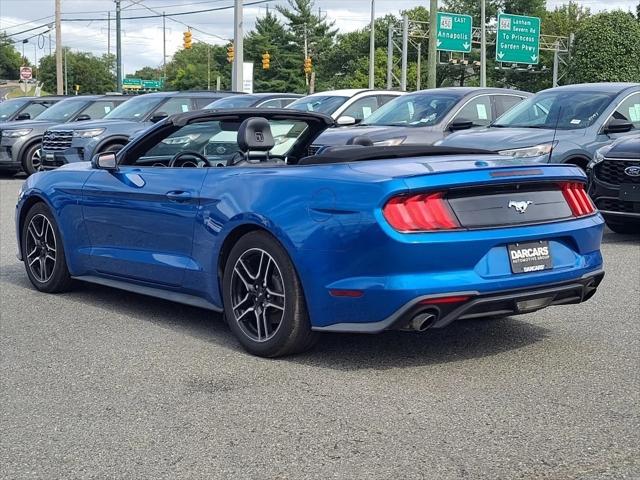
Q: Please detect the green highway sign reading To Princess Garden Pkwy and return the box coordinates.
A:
[496,13,540,65]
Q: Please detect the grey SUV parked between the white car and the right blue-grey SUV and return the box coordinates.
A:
[311,87,531,153]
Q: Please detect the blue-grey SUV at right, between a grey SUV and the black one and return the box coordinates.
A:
[436,83,640,169]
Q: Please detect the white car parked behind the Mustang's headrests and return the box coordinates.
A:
[286,88,404,125]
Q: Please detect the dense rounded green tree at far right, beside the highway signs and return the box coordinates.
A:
[569,11,640,83]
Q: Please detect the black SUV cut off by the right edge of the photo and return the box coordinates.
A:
[587,134,640,233]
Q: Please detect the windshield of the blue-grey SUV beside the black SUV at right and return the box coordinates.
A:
[492,91,616,130]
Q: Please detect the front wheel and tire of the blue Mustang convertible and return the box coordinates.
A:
[20,203,72,293]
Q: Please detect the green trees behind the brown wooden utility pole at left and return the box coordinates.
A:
[38,49,116,94]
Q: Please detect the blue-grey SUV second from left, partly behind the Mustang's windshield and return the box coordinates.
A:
[42,91,237,169]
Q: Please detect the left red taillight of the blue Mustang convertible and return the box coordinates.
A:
[383,192,460,232]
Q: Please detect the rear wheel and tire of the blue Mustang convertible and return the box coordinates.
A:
[222,231,317,358]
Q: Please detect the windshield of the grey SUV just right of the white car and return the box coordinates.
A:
[360,93,460,127]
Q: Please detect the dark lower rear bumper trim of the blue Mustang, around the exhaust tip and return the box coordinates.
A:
[314,270,604,333]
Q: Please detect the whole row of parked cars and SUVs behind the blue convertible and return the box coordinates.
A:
[0,83,640,231]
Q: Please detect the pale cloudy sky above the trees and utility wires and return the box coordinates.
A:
[0,0,638,73]
